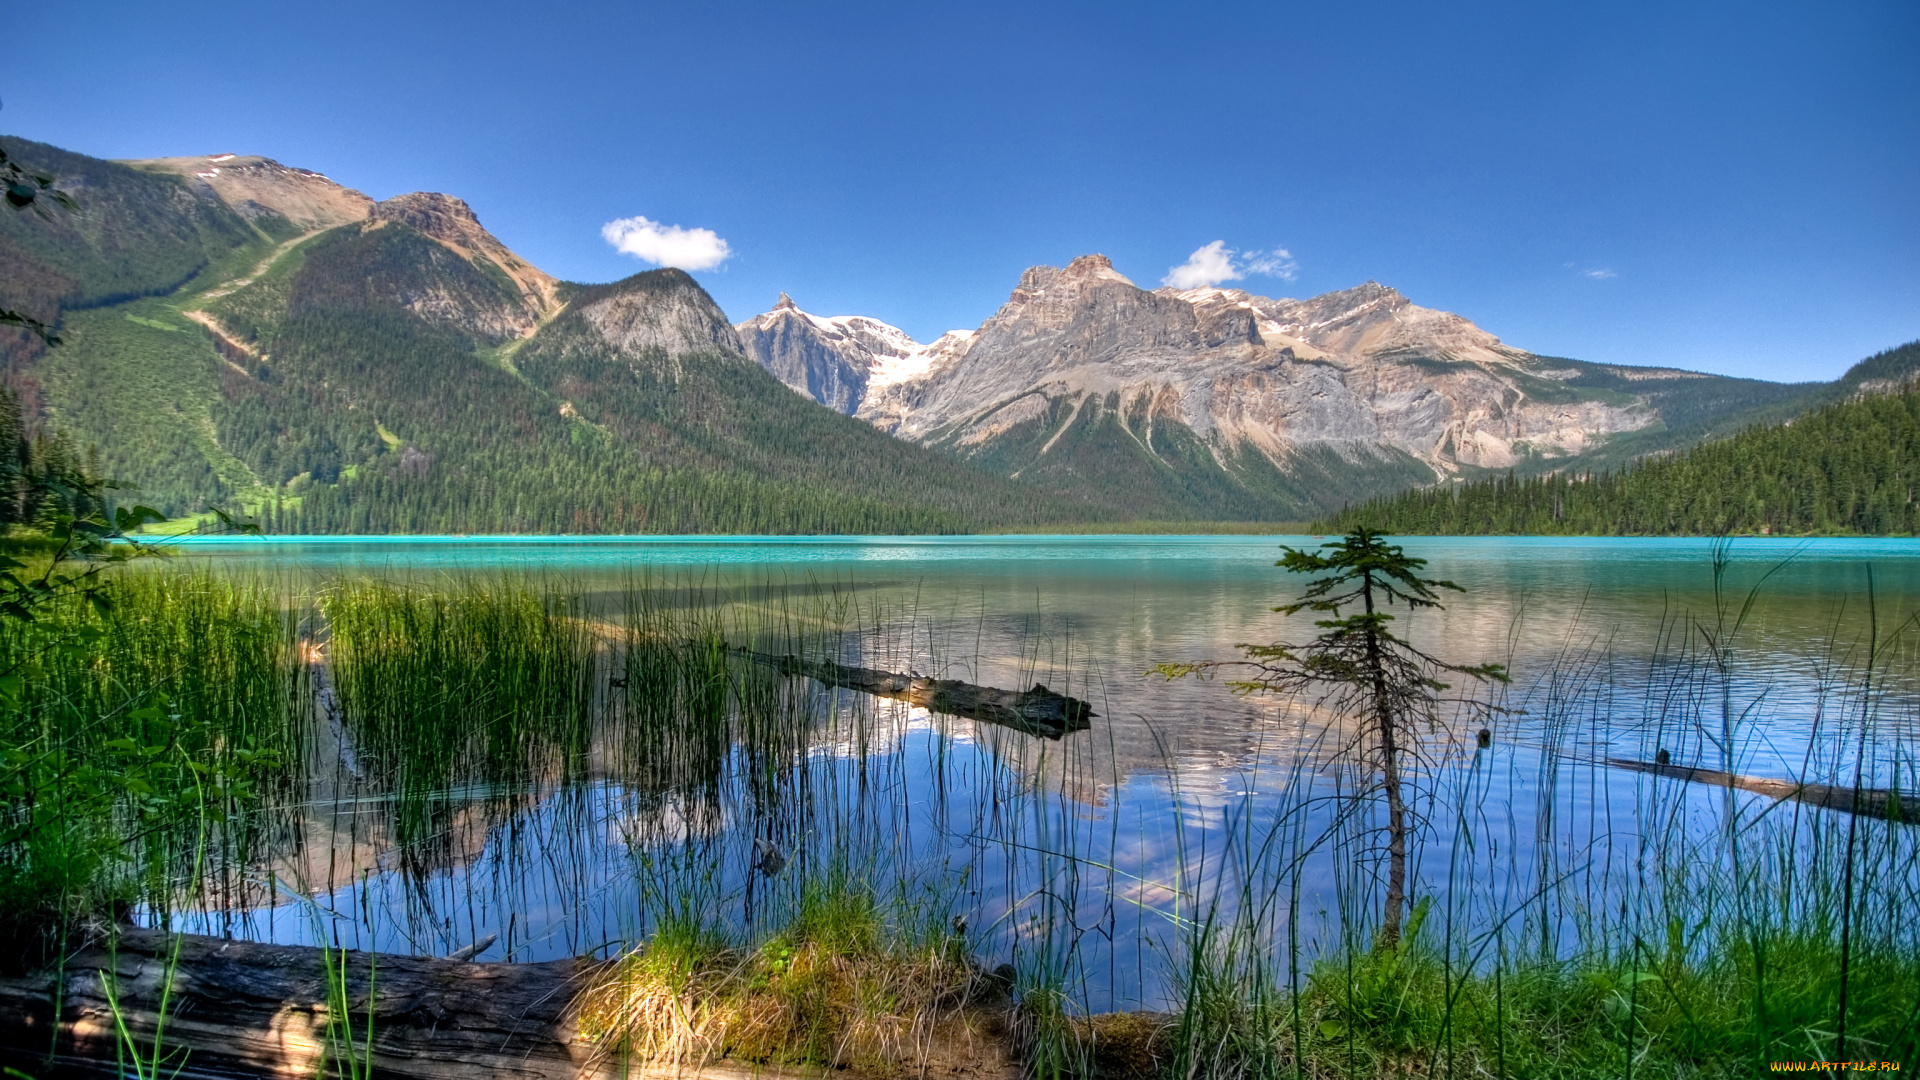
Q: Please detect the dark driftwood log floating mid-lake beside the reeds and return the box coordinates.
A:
[728,648,1098,738]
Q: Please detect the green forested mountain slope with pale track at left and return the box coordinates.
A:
[0,142,1110,532]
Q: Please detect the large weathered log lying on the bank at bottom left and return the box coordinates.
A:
[0,930,607,1080]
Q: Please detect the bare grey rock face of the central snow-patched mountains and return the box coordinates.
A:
[743,256,1655,473]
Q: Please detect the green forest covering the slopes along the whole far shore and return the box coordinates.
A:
[11,132,1920,534]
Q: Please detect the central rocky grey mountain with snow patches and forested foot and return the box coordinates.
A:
[737,256,1873,519]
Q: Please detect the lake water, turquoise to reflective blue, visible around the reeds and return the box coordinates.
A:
[157,536,1920,1007]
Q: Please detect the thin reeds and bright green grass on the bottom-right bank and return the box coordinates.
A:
[1128,567,1920,1078]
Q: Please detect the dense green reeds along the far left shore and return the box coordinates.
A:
[0,571,311,953]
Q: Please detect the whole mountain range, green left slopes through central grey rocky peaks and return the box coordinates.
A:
[0,140,1912,532]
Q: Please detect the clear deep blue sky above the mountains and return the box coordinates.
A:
[15,0,1920,380]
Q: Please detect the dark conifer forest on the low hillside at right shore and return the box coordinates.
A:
[1313,384,1920,536]
